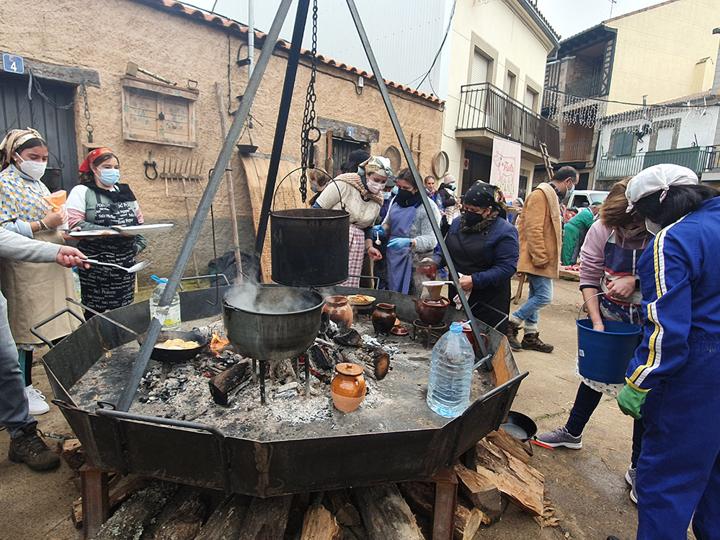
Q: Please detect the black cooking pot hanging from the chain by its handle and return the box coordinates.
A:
[270,173,350,287]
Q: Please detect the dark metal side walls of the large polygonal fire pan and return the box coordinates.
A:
[44,289,524,497]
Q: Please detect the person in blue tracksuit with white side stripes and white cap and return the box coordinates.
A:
[617,165,720,540]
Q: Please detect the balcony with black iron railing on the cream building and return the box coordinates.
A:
[455,83,560,159]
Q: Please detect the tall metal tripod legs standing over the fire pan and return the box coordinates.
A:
[117,0,491,411]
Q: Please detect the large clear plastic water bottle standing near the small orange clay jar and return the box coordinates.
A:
[427,322,475,418]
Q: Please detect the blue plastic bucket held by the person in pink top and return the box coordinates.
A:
[576,319,642,384]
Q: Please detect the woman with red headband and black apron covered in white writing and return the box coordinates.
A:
[67,148,146,318]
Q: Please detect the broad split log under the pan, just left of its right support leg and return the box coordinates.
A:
[353,484,423,540]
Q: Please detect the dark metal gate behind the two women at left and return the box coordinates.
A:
[0,72,78,191]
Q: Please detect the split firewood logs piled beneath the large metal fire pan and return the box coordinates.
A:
[77,431,557,540]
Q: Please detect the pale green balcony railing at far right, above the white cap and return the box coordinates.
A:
[597,146,720,180]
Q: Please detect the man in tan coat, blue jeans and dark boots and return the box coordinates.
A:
[507,167,579,353]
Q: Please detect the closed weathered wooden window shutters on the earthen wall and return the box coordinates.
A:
[122,77,199,147]
